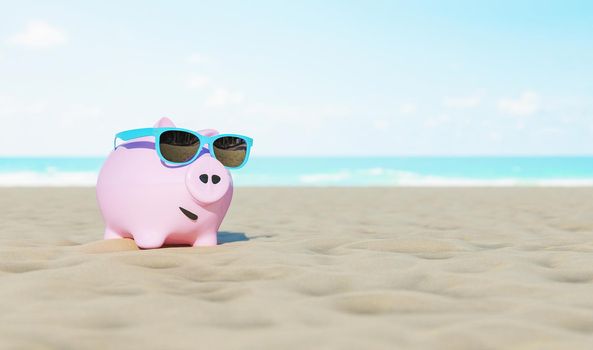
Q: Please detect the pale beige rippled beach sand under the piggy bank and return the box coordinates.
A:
[0,188,593,350]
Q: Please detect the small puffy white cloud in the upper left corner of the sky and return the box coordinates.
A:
[8,21,67,48]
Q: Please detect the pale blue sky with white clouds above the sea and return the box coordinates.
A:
[0,0,593,157]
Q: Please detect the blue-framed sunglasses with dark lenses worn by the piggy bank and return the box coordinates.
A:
[113,128,253,169]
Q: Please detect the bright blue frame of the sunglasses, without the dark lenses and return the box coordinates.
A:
[113,128,253,169]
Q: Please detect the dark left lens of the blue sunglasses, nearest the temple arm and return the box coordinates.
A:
[159,130,200,163]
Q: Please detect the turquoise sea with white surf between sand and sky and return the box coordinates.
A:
[0,157,593,186]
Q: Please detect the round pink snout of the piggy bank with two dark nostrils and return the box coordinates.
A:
[185,155,231,204]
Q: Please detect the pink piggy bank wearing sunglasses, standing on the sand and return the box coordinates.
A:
[97,118,250,248]
